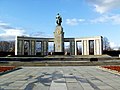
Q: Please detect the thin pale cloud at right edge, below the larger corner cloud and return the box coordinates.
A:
[90,14,120,24]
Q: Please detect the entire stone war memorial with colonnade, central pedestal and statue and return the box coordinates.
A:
[15,13,102,55]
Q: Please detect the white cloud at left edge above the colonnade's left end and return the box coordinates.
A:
[0,22,29,41]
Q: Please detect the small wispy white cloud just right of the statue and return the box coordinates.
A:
[66,18,85,26]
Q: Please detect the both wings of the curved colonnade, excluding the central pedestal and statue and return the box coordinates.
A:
[15,36,102,55]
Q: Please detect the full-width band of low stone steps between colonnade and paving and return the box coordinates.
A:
[0,56,120,66]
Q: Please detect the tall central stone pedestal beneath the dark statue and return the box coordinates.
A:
[54,25,64,52]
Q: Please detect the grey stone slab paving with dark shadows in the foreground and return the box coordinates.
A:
[0,66,120,90]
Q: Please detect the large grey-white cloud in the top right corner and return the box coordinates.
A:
[86,0,120,14]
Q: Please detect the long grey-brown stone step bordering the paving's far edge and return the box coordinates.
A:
[0,60,120,66]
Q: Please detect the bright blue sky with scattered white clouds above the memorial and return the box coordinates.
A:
[0,0,120,47]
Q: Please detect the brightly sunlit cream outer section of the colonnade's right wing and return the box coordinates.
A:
[75,36,103,55]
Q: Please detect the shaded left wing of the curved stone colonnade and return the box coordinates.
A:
[15,36,51,55]
